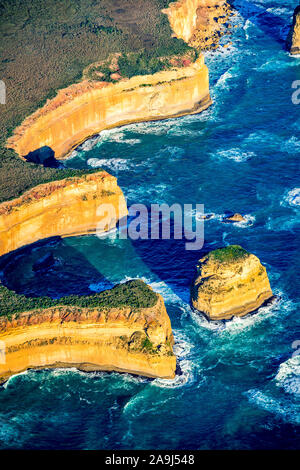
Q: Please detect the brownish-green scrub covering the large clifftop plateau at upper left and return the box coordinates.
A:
[0,0,192,202]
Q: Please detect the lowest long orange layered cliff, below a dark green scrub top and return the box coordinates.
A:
[0,281,176,383]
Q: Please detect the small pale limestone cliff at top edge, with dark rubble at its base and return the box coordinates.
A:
[163,0,231,49]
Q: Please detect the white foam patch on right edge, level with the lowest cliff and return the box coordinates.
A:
[275,355,300,396]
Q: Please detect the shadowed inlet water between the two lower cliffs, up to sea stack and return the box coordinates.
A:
[0,213,216,302]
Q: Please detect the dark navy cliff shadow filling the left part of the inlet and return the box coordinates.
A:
[0,237,115,298]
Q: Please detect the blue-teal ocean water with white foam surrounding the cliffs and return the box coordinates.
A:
[0,0,300,449]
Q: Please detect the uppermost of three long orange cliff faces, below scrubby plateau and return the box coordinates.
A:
[7,57,211,159]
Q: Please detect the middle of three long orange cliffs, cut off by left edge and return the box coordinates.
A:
[0,171,127,256]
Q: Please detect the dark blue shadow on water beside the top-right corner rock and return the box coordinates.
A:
[231,0,290,44]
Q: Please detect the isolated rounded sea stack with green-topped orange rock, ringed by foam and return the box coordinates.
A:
[191,245,273,320]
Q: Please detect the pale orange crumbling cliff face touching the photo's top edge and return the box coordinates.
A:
[163,0,227,43]
